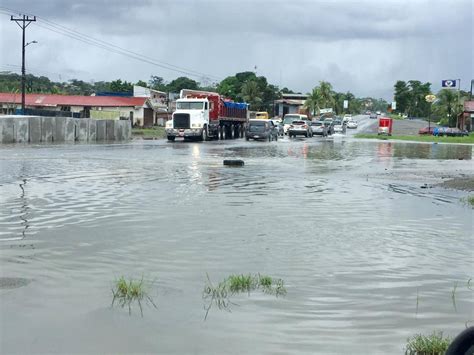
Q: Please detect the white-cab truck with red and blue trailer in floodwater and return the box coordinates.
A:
[166,89,248,141]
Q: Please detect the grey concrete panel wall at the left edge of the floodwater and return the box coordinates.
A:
[0,116,132,144]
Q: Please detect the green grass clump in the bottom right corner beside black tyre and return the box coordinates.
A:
[405,332,452,355]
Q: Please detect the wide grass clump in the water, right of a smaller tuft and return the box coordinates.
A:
[203,274,286,319]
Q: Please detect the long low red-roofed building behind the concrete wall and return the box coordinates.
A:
[0,93,155,126]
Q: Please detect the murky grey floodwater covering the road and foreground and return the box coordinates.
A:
[0,137,474,354]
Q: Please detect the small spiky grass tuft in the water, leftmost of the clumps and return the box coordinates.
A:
[112,276,158,317]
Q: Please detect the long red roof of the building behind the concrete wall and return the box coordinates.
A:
[0,93,148,107]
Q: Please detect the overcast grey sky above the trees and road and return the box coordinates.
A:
[0,0,474,100]
